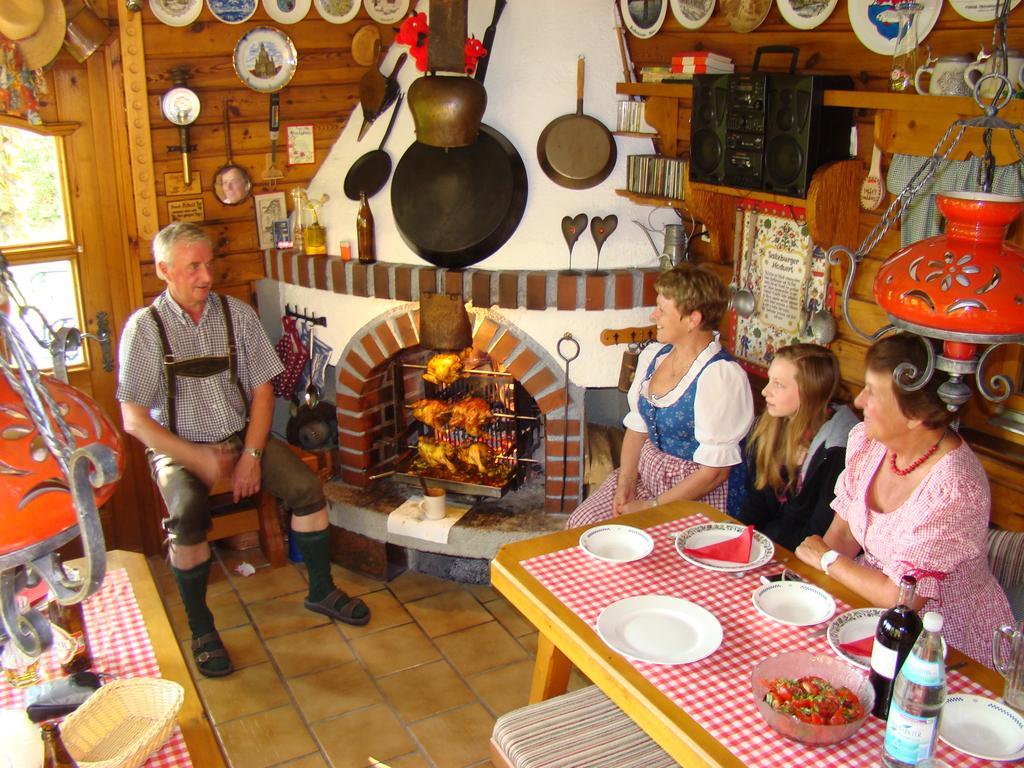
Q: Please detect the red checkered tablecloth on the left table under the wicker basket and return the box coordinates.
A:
[0,568,191,768]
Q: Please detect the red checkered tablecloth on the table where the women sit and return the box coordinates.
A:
[522,515,1007,768]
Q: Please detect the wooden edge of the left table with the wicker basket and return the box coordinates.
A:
[69,550,225,768]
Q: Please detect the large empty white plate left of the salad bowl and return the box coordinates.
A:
[597,595,722,664]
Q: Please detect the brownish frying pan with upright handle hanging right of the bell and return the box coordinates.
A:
[537,56,616,189]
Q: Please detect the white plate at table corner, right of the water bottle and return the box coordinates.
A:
[939,693,1024,760]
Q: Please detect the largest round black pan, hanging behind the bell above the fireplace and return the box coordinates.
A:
[391,0,528,269]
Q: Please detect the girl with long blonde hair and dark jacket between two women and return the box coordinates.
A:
[737,344,857,549]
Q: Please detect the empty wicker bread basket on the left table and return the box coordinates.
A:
[60,678,184,768]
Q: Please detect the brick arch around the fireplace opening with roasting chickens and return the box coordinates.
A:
[336,304,584,512]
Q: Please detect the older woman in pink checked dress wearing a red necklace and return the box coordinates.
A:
[797,334,1013,666]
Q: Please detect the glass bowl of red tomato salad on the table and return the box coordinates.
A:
[751,650,874,744]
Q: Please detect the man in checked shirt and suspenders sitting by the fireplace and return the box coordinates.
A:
[117,222,370,677]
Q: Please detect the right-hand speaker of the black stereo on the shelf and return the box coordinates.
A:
[762,75,853,198]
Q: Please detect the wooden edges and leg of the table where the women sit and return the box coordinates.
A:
[490,502,1001,768]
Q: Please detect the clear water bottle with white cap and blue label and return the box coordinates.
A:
[882,612,946,768]
